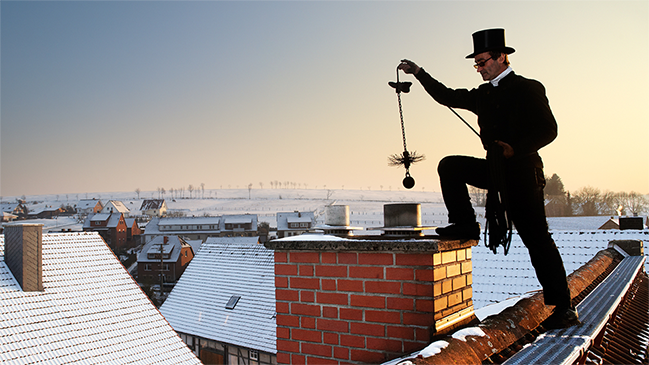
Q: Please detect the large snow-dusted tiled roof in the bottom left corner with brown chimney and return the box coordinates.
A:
[0,232,200,364]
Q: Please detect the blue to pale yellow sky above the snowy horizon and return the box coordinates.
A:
[0,1,649,196]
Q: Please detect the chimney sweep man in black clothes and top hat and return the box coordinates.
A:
[399,29,579,329]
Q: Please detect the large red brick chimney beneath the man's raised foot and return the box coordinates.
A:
[265,203,477,364]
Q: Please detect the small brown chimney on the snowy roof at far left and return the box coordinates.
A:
[4,224,43,291]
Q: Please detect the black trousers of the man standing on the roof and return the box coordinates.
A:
[437,156,571,306]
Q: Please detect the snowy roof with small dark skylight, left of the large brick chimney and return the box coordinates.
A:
[160,237,277,354]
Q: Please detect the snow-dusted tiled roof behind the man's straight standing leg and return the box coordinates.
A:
[472,228,649,308]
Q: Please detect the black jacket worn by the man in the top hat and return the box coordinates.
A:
[416,69,557,166]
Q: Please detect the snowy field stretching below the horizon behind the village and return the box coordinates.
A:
[2,188,636,232]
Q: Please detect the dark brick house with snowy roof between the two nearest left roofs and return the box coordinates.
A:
[137,236,195,284]
